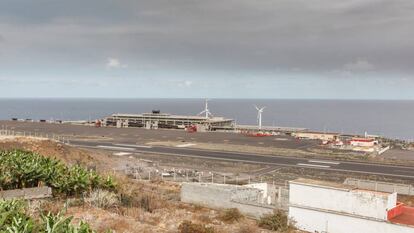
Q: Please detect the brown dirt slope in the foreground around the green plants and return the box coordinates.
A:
[0,137,284,233]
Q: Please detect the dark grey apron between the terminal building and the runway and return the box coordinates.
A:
[0,121,319,149]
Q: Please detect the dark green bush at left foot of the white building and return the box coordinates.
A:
[258,210,293,232]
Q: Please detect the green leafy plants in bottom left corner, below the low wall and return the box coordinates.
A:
[0,200,94,233]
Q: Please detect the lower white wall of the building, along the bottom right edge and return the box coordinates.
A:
[289,206,414,233]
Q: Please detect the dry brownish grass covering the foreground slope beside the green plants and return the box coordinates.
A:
[0,137,286,233]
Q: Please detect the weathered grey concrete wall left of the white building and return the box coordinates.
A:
[181,183,275,218]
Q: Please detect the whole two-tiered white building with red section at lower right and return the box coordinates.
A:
[289,179,414,233]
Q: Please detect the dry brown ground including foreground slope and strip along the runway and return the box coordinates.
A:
[0,136,414,233]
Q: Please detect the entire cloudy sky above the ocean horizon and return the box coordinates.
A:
[0,0,414,100]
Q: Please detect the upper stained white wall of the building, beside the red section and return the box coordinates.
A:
[289,182,397,220]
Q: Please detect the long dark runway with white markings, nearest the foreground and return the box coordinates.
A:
[71,141,414,180]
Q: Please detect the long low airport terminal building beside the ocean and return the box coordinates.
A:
[102,110,234,131]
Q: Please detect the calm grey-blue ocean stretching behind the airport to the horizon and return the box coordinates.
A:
[0,99,414,141]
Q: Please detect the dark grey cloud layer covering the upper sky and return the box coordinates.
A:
[0,0,414,74]
